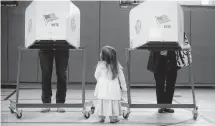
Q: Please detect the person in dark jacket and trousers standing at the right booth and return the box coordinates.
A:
[147,33,190,113]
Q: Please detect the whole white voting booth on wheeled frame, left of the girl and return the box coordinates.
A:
[9,0,94,119]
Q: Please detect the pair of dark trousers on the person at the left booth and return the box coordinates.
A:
[39,50,69,103]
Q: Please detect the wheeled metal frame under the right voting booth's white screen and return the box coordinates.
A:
[122,45,198,120]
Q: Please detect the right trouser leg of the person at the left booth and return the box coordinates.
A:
[55,50,69,103]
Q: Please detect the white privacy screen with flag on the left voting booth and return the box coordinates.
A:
[25,0,80,48]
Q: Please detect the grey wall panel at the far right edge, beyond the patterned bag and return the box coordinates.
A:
[191,7,215,84]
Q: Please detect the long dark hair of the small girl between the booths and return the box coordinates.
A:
[101,46,118,79]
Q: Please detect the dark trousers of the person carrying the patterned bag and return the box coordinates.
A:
[154,58,177,104]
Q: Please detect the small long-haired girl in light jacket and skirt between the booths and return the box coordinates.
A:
[94,46,127,123]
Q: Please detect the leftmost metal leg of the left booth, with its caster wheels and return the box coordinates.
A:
[9,48,22,119]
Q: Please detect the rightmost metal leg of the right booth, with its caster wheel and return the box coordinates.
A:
[187,52,198,120]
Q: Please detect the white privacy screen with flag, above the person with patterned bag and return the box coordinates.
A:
[129,1,184,49]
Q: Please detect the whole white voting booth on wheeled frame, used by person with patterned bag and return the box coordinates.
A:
[123,0,198,120]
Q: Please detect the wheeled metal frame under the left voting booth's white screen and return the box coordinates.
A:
[9,47,95,119]
